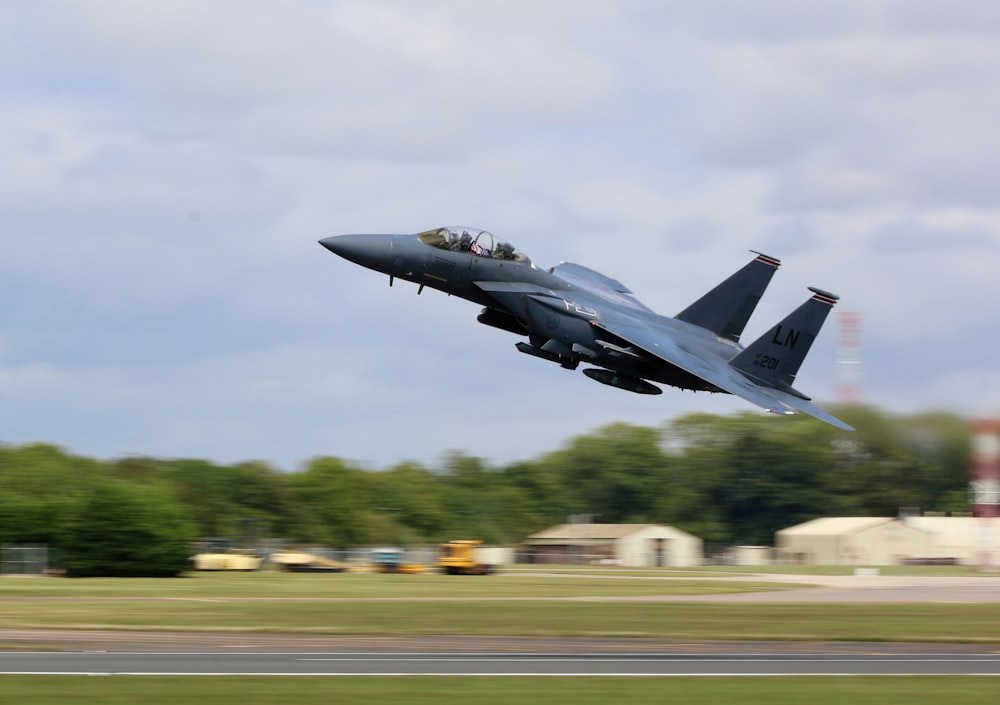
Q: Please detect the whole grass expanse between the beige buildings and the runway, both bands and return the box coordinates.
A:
[0,571,1000,643]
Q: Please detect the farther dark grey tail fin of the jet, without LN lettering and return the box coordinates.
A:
[677,250,781,341]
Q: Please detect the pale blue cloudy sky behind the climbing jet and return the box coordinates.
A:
[0,0,1000,471]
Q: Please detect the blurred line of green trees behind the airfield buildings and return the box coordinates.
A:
[0,406,972,575]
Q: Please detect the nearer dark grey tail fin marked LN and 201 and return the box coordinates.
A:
[729,287,840,399]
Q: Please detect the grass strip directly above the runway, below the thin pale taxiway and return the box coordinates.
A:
[0,598,1000,642]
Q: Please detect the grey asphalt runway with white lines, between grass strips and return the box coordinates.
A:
[0,649,1000,676]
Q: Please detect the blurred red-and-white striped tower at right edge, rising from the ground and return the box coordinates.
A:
[969,419,1000,570]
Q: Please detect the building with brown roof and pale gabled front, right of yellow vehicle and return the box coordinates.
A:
[524,524,704,568]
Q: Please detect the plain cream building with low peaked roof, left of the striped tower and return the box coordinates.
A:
[776,517,931,566]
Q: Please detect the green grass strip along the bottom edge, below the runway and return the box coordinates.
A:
[0,676,997,705]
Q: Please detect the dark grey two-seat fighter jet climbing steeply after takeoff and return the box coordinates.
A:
[319,226,854,431]
